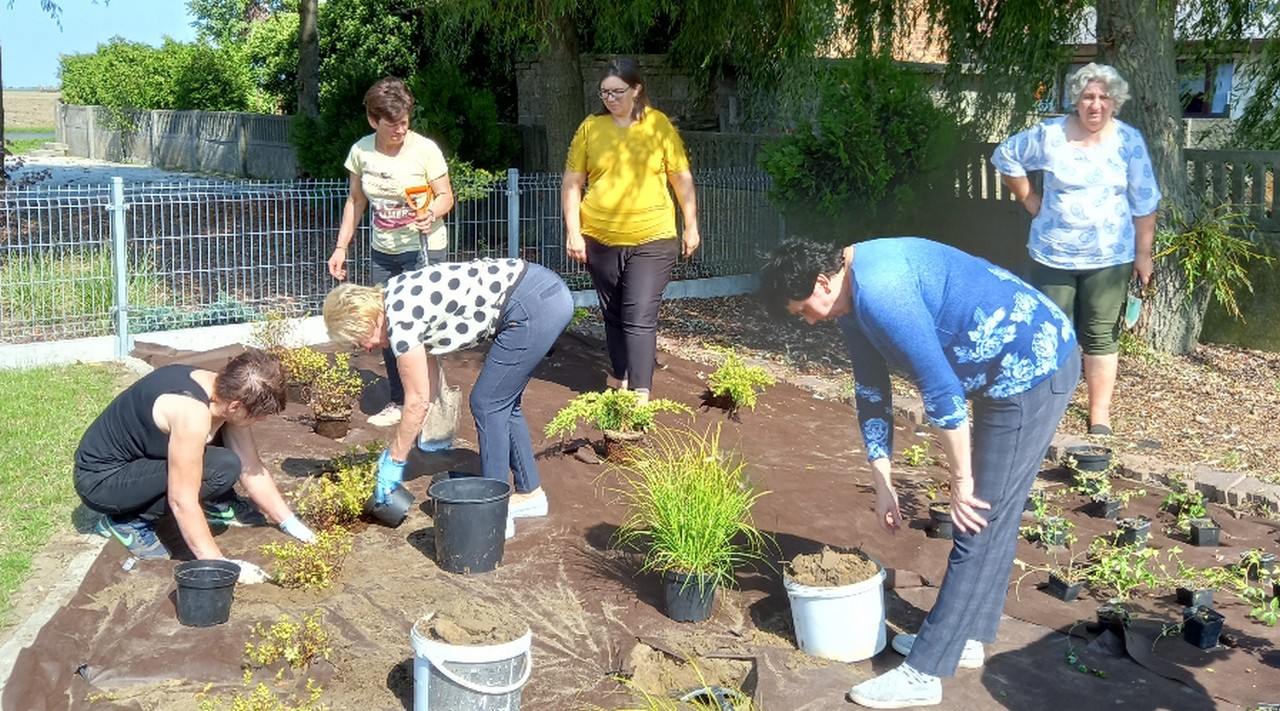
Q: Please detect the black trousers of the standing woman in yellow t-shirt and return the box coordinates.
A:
[586,237,680,389]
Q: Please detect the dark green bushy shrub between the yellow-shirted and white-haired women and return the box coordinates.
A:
[760,59,960,217]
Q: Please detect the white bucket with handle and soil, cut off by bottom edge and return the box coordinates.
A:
[410,615,534,711]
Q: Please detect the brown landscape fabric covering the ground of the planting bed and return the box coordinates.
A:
[3,333,1280,711]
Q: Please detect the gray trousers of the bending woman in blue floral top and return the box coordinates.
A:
[906,352,1080,676]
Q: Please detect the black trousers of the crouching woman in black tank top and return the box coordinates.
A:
[76,446,241,521]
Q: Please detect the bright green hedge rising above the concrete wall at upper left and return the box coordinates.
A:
[59,37,250,111]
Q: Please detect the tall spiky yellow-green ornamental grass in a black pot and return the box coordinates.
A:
[605,427,772,587]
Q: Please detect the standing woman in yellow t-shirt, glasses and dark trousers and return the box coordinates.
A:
[561,58,701,401]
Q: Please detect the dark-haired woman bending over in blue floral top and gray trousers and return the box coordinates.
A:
[760,237,1080,708]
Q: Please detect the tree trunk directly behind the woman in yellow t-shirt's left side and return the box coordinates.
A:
[539,13,584,170]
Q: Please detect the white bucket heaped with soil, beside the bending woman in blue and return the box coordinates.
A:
[782,561,884,661]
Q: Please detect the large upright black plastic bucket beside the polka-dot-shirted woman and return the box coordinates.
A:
[426,477,511,574]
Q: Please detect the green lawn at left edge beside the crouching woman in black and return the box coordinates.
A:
[0,365,123,624]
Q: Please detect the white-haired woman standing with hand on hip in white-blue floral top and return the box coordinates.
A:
[991,63,1161,436]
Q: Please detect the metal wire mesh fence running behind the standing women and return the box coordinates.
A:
[0,170,782,345]
